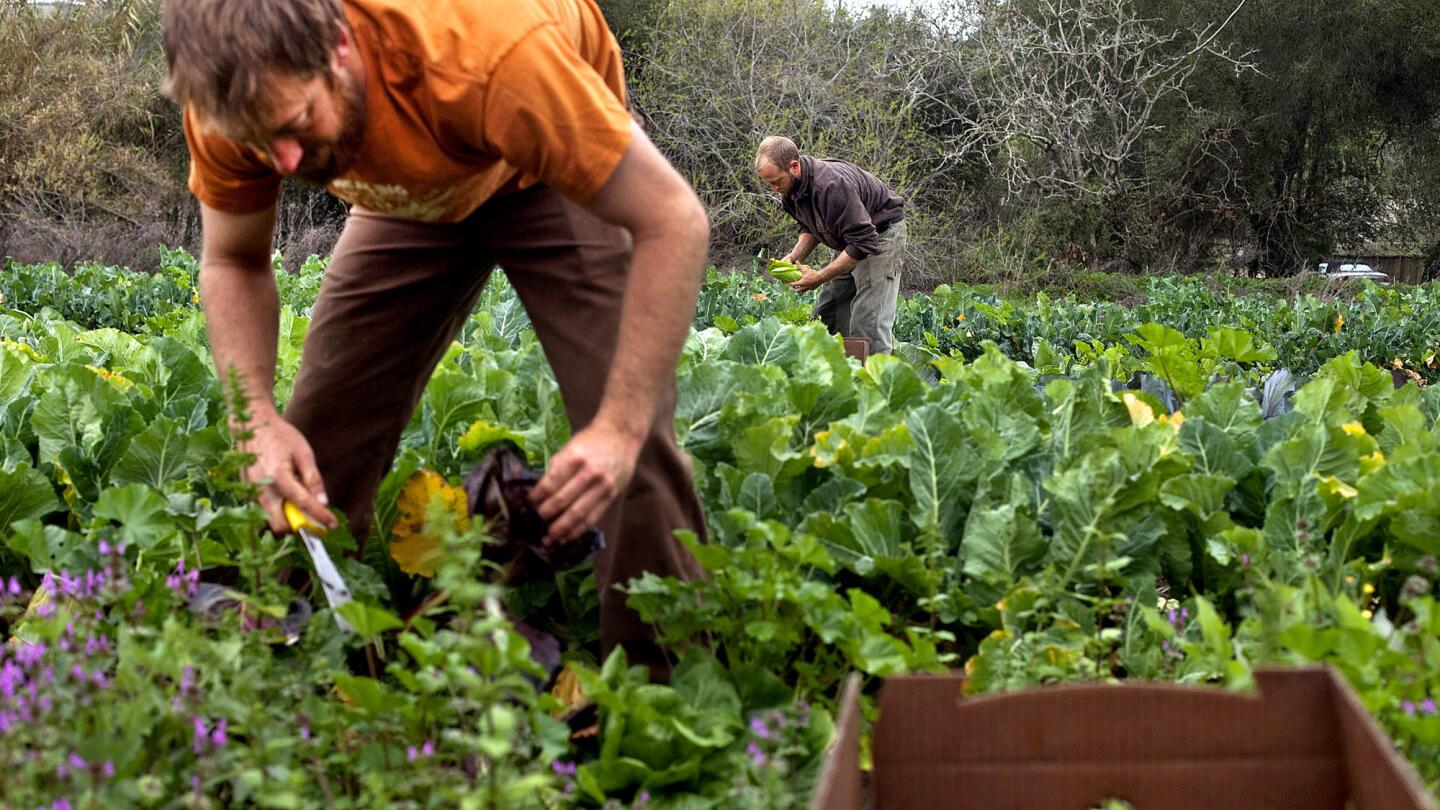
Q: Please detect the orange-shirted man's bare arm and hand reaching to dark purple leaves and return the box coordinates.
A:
[533,127,710,539]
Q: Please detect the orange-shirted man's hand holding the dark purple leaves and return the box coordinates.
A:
[530,422,641,545]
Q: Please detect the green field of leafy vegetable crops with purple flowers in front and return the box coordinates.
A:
[0,252,1440,810]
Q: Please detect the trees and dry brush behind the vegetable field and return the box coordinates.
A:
[0,0,1440,275]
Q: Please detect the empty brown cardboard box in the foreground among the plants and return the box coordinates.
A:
[811,667,1436,810]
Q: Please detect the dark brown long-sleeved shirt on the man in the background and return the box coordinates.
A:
[780,154,904,261]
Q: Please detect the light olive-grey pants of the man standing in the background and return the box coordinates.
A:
[814,219,906,355]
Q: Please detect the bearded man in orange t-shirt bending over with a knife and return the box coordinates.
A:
[166,0,708,676]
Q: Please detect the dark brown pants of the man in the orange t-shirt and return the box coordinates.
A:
[285,187,704,677]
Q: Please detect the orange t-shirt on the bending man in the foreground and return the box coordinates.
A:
[184,0,631,222]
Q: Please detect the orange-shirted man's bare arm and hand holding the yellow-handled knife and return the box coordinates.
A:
[200,203,336,532]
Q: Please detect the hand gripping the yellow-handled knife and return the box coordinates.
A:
[240,414,338,535]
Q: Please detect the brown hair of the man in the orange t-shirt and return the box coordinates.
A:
[161,0,346,128]
